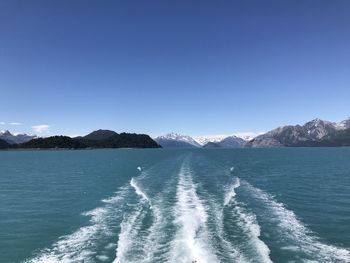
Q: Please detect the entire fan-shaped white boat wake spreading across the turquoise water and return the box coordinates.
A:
[25,156,350,263]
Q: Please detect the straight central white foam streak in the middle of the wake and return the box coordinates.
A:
[170,165,218,263]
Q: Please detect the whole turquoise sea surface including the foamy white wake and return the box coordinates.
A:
[0,148,350,263]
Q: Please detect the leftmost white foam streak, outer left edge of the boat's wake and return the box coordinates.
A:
[25,187,128,263]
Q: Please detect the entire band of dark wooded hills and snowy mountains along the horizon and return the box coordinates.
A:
[0,118,350,149]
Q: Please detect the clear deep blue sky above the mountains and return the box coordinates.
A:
[0,0,350,135]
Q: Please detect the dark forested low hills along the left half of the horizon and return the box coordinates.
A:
[0,130,161,149]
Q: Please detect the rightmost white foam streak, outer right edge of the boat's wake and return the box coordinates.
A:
[245,182,350,263]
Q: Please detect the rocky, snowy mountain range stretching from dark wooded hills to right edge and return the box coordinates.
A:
[154,118,350,148]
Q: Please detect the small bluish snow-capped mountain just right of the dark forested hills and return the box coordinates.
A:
[154,132,201,148]
